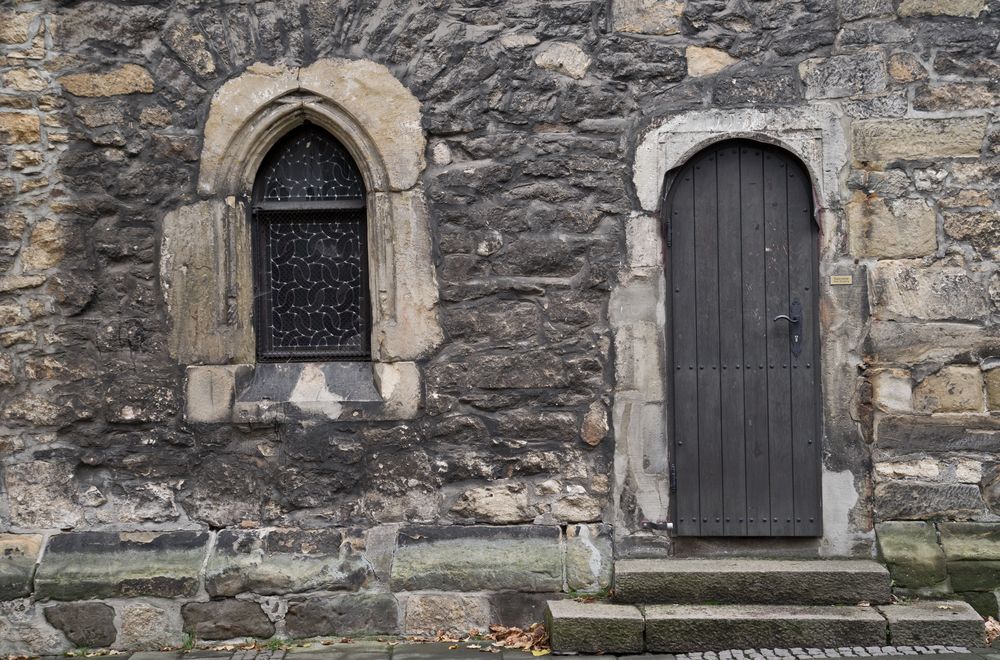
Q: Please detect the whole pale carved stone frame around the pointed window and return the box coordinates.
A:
[160,59,443,423]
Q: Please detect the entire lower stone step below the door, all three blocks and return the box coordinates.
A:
[545,600,985,655]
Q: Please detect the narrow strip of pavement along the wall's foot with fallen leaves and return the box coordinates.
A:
[27,642,1000,660]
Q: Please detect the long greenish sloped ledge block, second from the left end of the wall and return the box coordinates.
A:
[35,532,208,600]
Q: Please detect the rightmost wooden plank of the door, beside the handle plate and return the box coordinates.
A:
[786,162,822,536]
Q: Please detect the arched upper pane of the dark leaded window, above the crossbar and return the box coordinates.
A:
[257,124,365,201]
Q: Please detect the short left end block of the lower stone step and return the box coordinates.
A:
[545,600,644,655]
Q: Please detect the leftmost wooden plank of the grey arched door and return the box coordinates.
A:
[668,166,701,535]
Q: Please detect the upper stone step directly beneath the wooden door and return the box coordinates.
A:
[614,559,891,605]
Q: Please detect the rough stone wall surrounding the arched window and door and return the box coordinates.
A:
[0,0,1000,654]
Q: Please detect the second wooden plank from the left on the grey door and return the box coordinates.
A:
[694,151,726,536]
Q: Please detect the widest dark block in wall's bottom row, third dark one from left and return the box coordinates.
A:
[285,594,400,638]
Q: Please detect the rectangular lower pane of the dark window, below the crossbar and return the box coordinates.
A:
[259,209,369,358]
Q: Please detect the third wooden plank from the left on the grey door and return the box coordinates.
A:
[716,145,747,536]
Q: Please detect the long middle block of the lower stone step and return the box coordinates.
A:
[645,605,887,653]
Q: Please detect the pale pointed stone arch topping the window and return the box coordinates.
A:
[198,59,426,196]
